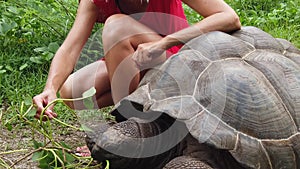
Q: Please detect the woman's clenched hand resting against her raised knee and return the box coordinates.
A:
[132,41,166,69]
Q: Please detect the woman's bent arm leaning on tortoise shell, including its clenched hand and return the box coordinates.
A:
[132,0,241,69]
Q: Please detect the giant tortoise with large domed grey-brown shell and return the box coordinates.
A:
[87,27,300,169]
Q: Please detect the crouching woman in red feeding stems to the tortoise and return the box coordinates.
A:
[33,0,241,156]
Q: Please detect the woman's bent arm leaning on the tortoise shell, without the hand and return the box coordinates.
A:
[159,0,241,49]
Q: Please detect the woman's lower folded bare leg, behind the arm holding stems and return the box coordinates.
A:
[60,60,113,109]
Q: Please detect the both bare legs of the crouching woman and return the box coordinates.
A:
[60,14,165,109]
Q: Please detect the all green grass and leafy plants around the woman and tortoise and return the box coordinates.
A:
[0,0,300,168]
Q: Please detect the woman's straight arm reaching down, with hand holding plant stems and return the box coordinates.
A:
[33,0,98,119]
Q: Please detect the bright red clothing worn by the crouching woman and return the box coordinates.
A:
[91,0,189,56]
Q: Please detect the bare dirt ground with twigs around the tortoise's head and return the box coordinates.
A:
[0,105,111,169]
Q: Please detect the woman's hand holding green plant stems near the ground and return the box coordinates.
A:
[32,90,57,121]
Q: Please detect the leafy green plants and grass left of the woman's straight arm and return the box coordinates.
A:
[0,0,77,112]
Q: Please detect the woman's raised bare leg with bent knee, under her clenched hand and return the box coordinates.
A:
[102,14,165,103]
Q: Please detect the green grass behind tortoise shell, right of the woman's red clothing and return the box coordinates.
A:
[185,0,300,48]
